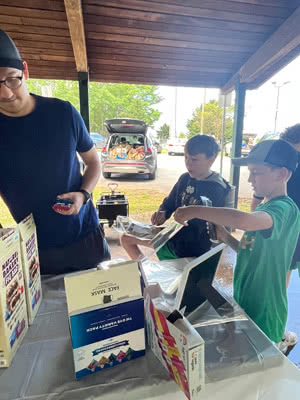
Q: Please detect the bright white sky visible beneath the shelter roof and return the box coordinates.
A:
[154,56,300,140]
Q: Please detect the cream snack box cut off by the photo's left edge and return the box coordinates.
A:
[0,228,28,368]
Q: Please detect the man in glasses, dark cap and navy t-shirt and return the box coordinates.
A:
[0,29,110,274]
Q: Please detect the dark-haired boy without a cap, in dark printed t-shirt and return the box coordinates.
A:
[121,135,231,260]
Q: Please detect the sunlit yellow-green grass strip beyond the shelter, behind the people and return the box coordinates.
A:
[0,186,251,227]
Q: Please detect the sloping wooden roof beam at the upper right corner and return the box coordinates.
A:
[222,7,300,93]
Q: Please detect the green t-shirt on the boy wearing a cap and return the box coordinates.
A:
[233,196,300,343]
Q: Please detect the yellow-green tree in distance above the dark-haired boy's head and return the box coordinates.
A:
[187,100,233,143]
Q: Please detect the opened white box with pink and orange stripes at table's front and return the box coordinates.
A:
[145,295,205,400]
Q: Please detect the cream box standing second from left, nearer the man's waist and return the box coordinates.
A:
[18,214,42,325]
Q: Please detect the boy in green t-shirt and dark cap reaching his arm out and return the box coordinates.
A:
[174,140,300,343]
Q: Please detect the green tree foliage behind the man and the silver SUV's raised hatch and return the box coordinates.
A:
[27,79,162,133]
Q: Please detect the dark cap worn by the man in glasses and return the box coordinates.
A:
[0,29,24,71]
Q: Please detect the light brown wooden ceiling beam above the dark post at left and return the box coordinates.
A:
[64,0,88,72]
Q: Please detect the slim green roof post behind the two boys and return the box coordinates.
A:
[230,80,246,208]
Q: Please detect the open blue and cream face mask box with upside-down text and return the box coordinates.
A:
[65,261,145,378]
